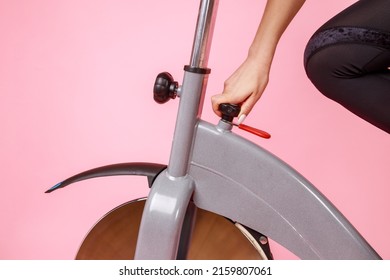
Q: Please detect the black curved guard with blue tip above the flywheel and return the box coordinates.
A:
[45,162,167,193]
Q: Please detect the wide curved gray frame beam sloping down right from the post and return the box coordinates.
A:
[189,121,380,259]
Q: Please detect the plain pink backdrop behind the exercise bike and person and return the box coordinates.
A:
[0,0,390,259]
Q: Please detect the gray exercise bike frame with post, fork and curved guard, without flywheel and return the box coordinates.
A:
[48,0,380,259]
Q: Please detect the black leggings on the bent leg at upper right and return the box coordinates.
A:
[304,0,390,133]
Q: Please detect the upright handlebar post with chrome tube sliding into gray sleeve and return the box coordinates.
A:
[168,0,218,178]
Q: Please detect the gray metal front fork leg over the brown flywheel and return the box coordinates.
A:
[134,172,194,260]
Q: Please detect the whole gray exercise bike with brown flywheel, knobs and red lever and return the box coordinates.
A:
[47,0,381,260]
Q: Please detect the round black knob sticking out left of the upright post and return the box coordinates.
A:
[153,72,179,104]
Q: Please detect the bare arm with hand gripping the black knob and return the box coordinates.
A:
[211,0,305,121]
